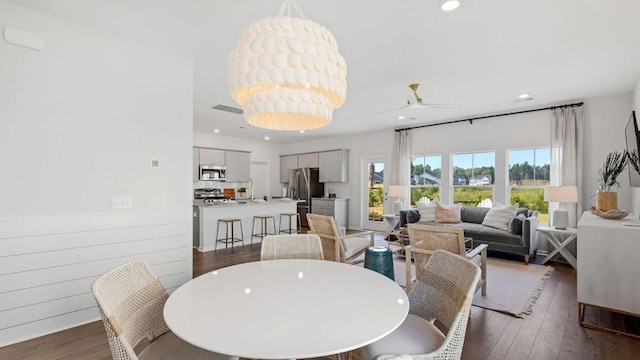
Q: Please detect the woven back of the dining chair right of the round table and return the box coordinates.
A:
[409,250,480,359]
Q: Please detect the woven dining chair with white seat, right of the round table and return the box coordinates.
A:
[363,250,480,360]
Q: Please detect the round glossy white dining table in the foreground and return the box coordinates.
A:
[164,260,409,359]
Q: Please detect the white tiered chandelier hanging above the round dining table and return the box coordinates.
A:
[227,0,347,130]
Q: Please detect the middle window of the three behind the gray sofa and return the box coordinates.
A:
[452,152,495,206]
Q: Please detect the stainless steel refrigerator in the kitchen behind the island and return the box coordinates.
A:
[289,168,324,226]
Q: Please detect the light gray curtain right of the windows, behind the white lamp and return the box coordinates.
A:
[549,106,583,229]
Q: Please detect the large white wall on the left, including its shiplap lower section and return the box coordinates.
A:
[0,0,193,346]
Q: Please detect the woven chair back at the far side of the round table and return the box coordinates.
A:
[260,234,324,260]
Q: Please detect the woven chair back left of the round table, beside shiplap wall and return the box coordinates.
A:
[91,260,169,360]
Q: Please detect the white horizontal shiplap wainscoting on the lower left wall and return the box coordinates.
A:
[0,207,193,346]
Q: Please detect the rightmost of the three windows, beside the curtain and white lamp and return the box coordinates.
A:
[508,147,551,224]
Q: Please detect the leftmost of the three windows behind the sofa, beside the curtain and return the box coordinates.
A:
[411,155,442,205]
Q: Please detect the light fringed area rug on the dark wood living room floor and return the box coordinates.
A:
[372,256,554,318]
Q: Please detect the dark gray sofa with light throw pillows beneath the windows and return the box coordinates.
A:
[398,206,539,264]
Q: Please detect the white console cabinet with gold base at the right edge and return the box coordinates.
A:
[577,212,640,337]
